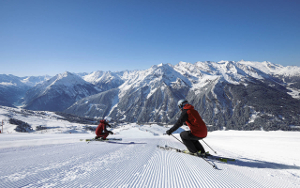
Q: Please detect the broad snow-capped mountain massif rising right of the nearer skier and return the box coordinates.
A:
[170,61,300,130]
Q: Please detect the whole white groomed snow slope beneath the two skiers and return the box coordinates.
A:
[0,124,300,188]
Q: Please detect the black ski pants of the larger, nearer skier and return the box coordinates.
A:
[180,131,205,153]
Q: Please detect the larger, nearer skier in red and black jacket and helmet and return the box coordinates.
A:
[166,99,207,156]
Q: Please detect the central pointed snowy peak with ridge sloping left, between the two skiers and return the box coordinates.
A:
[65,64,191,122]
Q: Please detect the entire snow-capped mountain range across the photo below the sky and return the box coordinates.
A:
[0,60,300,130]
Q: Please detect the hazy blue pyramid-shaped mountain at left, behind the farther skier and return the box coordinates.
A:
[24,72,98,111]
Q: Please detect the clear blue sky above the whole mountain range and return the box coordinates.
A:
[0,0,300,76]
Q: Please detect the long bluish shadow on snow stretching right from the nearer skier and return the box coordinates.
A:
[223,158,300,170]
